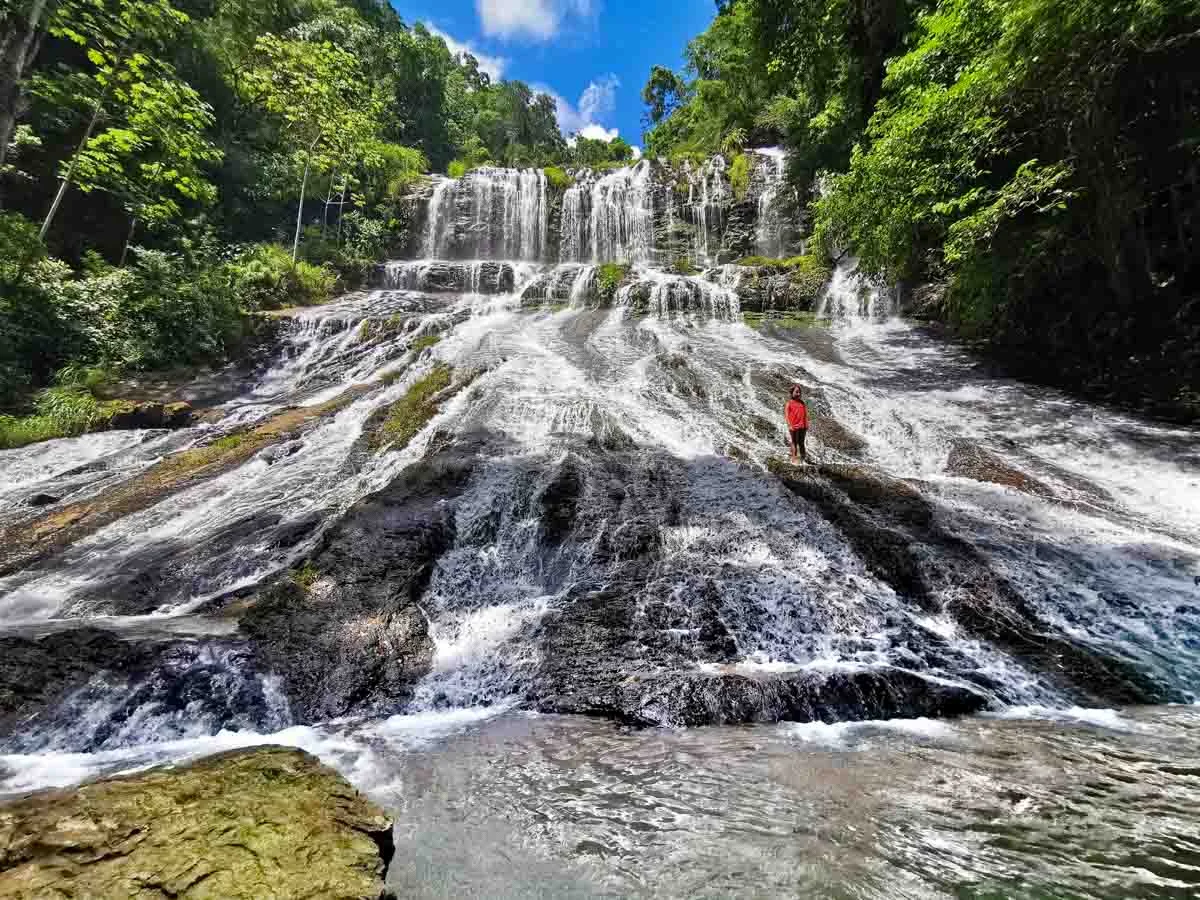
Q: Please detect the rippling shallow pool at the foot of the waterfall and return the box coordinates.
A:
[0,707,1200,899]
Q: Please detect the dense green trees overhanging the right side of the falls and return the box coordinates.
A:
[643,0,1200,415]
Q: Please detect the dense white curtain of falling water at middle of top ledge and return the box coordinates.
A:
[581,160,654,263]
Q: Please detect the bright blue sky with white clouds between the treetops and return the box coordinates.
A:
[392,0,716,151]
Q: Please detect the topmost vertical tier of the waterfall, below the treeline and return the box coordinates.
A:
[409,150,802,266]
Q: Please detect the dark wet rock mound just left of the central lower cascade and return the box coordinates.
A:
[240,446,475,722]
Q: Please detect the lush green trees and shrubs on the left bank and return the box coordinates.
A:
[0,0,580,410]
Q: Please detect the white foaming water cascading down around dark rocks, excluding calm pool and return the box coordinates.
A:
[0,163,1200,854]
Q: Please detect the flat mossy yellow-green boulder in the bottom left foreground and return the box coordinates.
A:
[0,746,395,900]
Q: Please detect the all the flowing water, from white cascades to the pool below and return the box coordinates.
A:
[0,154,1200,898]
